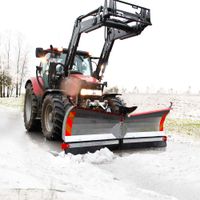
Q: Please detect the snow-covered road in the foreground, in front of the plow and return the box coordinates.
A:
[0,108,200,200]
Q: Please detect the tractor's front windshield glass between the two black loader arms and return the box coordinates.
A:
[71,55,92,76]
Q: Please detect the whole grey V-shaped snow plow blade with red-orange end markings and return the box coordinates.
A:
[62,106,171,153]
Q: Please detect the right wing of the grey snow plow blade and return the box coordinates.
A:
[123,108,171,148]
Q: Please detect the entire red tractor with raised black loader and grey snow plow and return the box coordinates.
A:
[24,0,171,153]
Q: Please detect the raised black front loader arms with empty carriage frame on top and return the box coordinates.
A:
[65,0,151,80]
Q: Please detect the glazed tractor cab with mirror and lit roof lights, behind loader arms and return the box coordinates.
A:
[36,48,93,89]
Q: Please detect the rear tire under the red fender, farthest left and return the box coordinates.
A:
[24,83,41,132]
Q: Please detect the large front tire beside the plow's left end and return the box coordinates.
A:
[41,95,65,140]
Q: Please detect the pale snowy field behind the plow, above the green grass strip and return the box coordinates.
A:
[122,94,200,119]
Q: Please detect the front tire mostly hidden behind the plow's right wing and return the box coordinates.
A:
[106,97,125,114]
